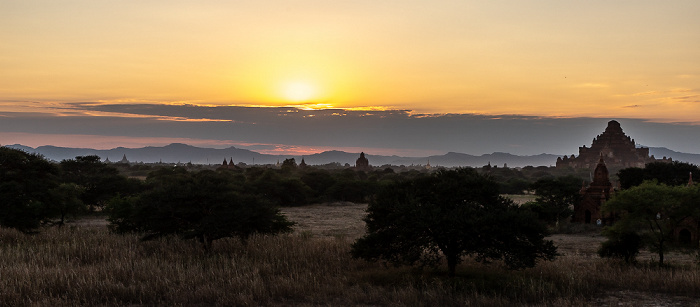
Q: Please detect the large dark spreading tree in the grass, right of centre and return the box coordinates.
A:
[352,168,556,277]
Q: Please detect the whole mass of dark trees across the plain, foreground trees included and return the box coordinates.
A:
[0,147,700,275]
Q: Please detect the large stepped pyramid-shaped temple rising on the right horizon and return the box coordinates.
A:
[557,120,672,169]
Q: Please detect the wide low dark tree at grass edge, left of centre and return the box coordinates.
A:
[109,169,293,250]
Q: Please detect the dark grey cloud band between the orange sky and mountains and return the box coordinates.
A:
[0,103,700,155]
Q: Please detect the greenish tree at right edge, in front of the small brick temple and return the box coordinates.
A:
[603,181,700,266]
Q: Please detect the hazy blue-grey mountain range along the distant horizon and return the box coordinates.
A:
[6,143,700,167]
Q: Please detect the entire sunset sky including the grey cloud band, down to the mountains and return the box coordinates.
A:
[0,0,700,156]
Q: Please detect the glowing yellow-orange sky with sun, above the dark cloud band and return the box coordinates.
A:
[0,0,700,122]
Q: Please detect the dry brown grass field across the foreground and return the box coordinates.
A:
[0,203,700,306]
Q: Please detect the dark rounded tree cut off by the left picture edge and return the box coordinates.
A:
[0,147,59,233]
